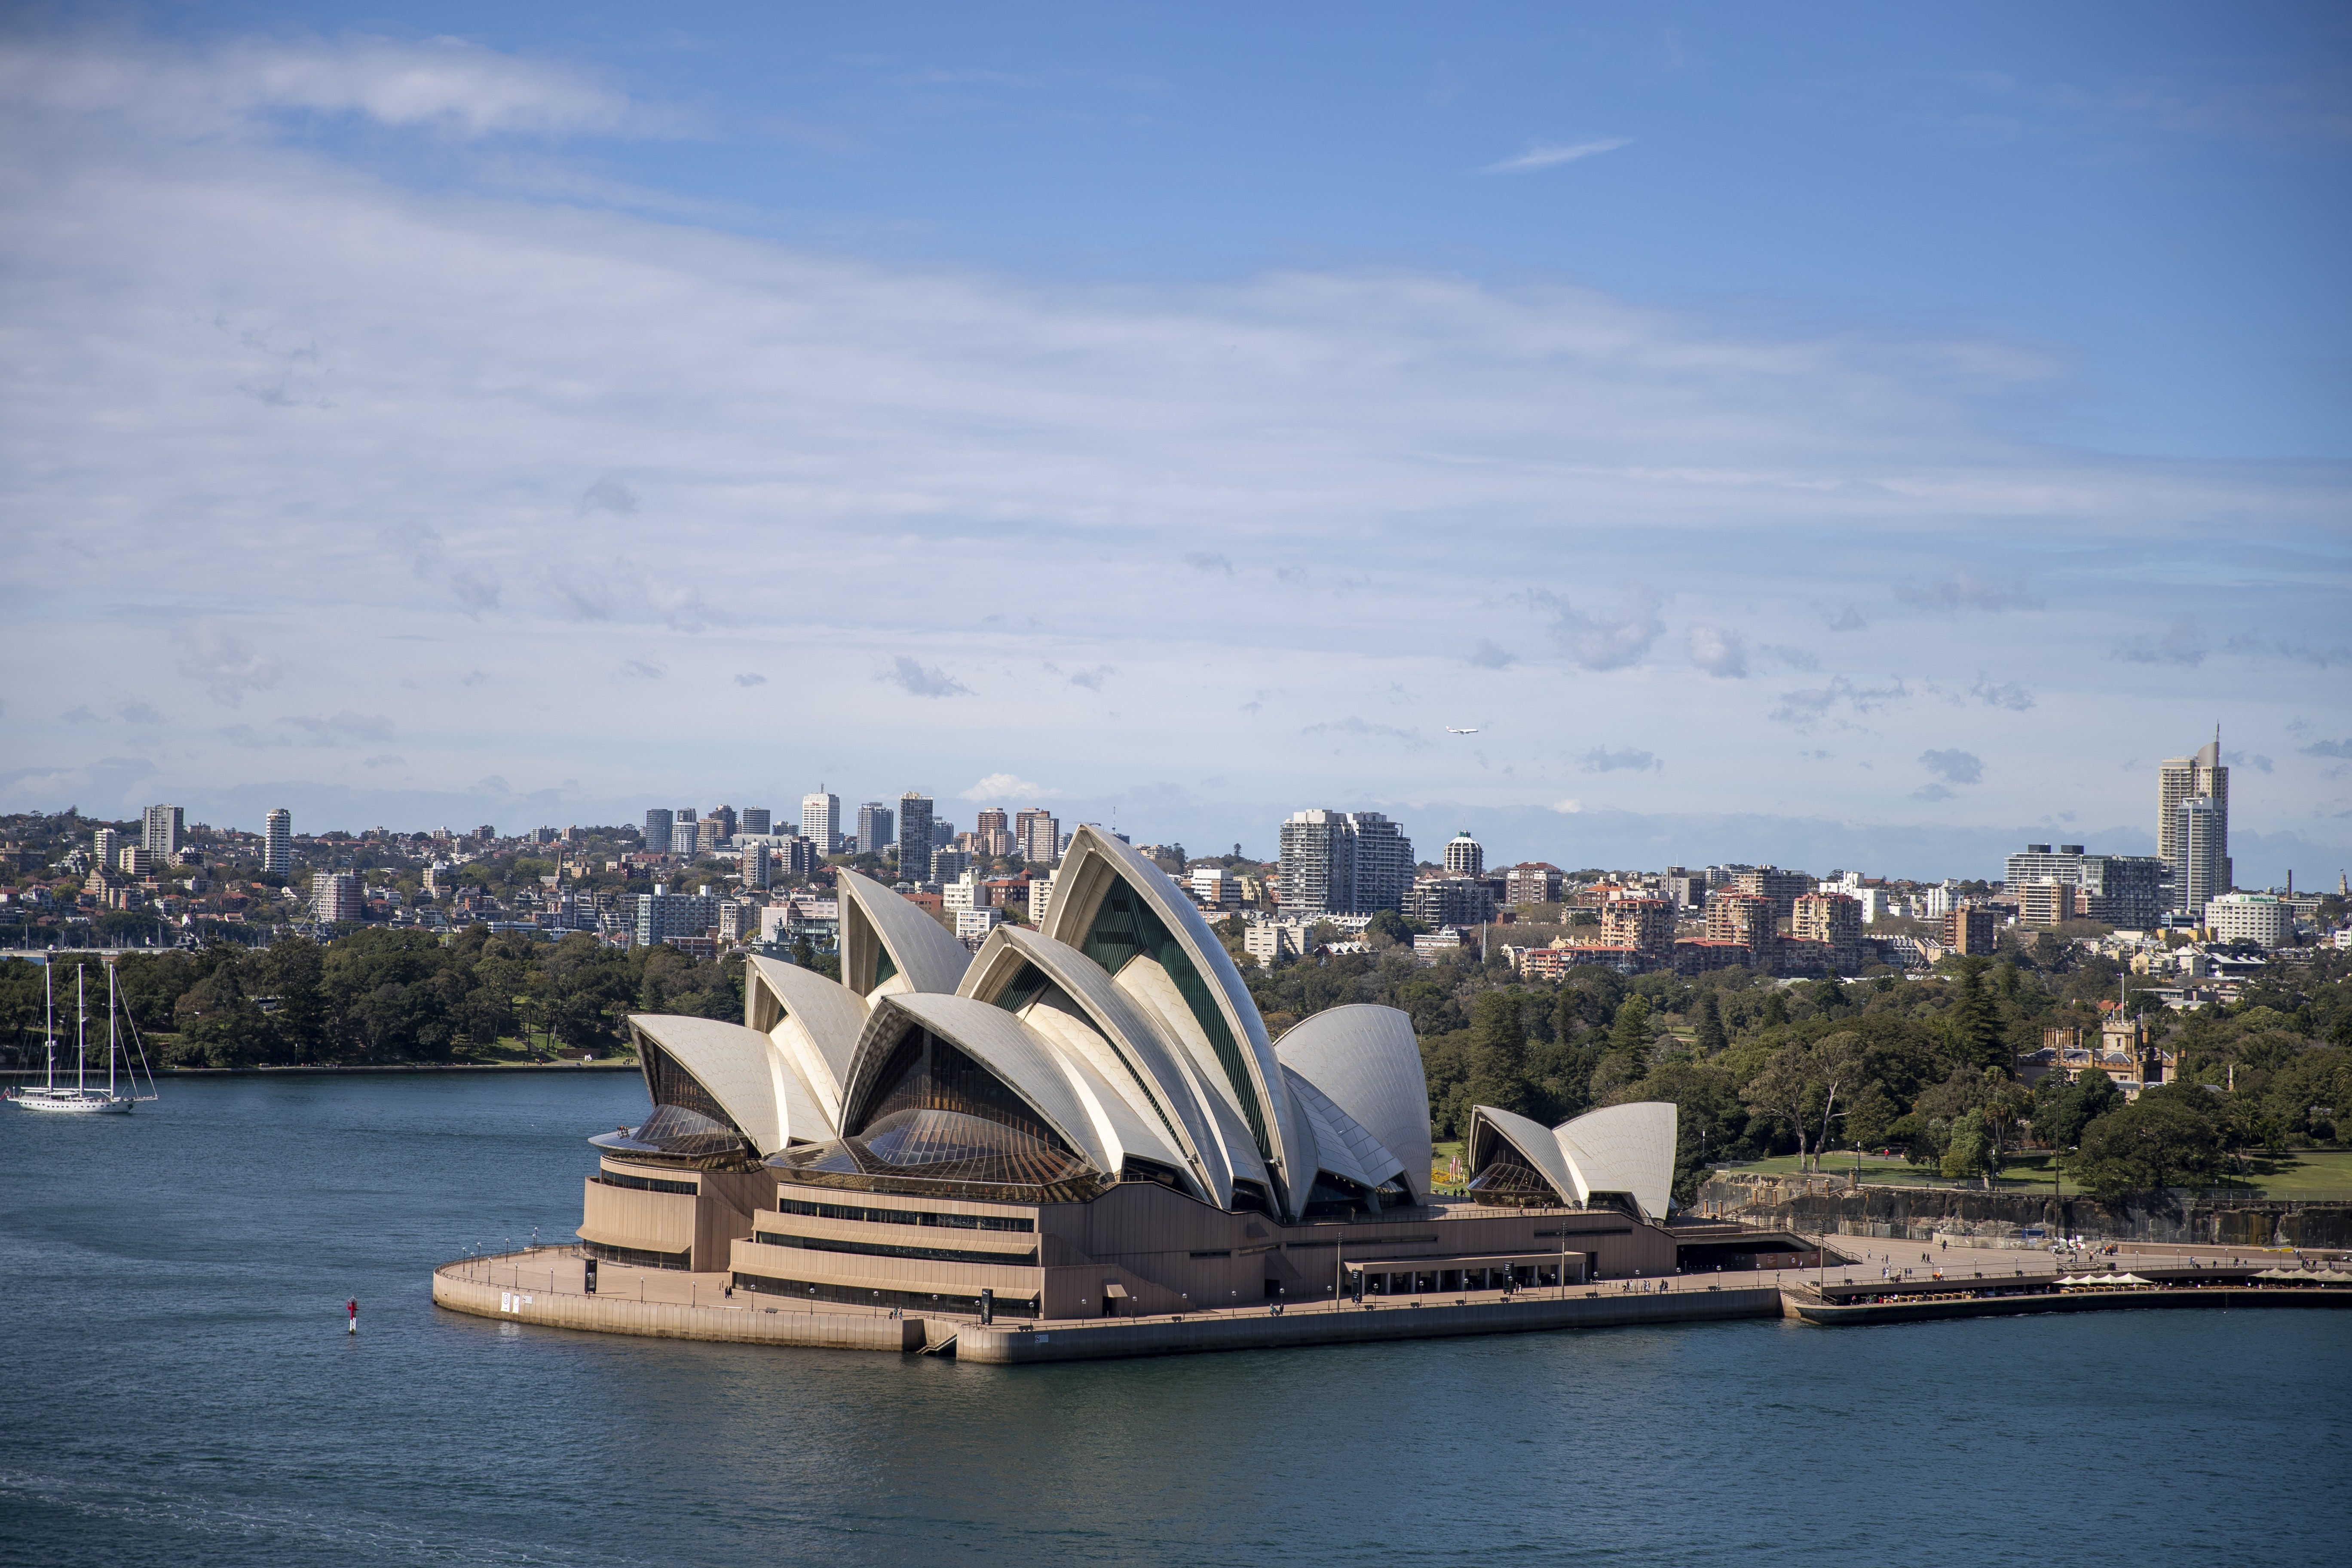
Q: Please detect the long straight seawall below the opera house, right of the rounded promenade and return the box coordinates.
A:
[955,1286,1783,1366]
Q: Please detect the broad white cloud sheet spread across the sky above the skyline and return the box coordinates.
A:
[0,21,2352,858]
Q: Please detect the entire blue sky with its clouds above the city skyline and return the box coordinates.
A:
[0,5,2352,882]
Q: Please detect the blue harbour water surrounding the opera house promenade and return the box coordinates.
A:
[0,1074,2352,1568]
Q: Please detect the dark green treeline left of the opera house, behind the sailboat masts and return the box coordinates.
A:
[0,926,743,1067]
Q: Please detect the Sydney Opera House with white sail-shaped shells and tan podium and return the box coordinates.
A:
[579,827,1675,1319]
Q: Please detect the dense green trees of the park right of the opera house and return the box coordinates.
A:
[1251,943,2352,1201]
